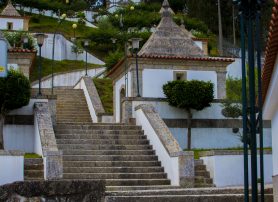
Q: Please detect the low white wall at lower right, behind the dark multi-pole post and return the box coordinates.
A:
[201,154,272,187]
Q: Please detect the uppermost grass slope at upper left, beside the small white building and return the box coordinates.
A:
[27,13,94,38]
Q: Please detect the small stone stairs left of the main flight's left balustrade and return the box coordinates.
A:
[24,158,44,181]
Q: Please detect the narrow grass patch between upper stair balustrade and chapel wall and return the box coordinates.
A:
[93,78,113,113]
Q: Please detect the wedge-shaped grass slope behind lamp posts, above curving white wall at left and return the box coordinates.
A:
[30,57,100,82]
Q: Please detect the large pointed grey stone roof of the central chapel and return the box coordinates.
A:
[138,0,205,57]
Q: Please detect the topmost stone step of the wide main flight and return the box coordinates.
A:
[55,124,142,131]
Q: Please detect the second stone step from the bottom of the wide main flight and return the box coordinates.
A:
[63,172,167,179]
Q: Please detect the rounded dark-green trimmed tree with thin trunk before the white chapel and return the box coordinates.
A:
[163,80,214,149]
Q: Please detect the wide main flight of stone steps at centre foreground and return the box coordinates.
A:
[55,123,170,187]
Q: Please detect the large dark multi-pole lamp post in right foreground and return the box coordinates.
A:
[234,0,266,202]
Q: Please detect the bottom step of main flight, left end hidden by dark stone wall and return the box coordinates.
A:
[105,179,170,186]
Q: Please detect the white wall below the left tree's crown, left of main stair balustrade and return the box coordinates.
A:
[4,125,34,153]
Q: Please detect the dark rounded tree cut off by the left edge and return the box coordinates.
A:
[0,70,31,149]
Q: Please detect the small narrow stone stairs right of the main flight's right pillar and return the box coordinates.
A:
[194,159,215,188]
